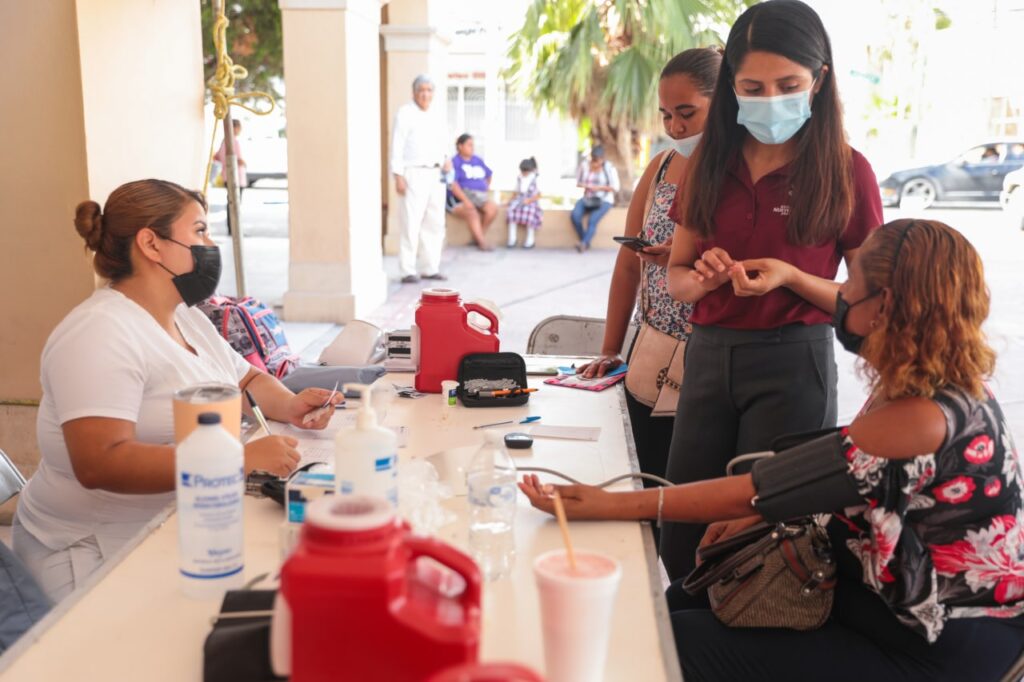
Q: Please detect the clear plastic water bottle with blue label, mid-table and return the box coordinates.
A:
[466,432,516,581]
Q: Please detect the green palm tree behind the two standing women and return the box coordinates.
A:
[503,0,754,199]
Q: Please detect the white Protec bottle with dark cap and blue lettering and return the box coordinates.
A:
[175,412,246,599]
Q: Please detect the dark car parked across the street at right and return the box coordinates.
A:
[879,140,1024,208]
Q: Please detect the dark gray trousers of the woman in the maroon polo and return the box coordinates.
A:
[660,325,838,581]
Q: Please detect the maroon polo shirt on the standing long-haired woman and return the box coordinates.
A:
[670,150,882,330]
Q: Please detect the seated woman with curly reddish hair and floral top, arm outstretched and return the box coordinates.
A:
[520,220,1024,681]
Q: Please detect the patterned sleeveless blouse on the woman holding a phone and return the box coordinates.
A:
[633,151,693,341]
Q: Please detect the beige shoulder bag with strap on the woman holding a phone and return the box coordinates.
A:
[626,155,686,417]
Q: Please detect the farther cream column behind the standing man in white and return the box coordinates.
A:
[380,0,455,255]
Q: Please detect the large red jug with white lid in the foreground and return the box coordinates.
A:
[281,496,480,682]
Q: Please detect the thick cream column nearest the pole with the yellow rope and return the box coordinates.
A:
[279,0,387,323]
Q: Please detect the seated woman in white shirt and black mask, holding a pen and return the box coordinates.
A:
[12,180,340,601]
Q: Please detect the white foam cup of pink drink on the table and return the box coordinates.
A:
[534,550,623,682]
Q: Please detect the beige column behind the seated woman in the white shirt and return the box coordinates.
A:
[0,0,205,516]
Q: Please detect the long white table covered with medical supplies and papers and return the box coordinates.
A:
[0,375,682,682]
